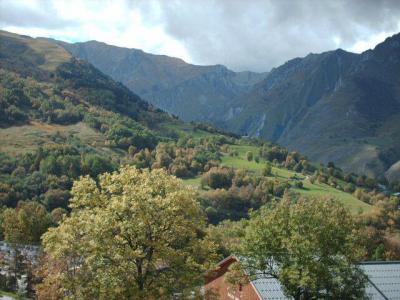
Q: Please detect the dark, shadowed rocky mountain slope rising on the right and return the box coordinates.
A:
[225,35,400,180]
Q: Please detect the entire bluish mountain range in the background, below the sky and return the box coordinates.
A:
[48,35,400,180]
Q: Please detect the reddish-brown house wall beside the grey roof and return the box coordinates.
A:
[204,258,261,300]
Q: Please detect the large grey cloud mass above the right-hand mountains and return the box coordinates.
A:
[155,0,400,71]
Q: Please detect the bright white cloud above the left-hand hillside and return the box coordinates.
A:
[0,0,191,61]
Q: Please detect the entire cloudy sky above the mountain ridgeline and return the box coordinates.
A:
[0,0,400,72]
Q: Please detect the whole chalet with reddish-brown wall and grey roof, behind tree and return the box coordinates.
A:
[204,256,400,300]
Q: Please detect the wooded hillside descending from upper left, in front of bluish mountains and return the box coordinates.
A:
[0,32,386,218]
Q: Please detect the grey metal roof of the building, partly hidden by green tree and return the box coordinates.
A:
[252,262,400,300]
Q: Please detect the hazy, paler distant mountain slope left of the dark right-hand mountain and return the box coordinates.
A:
[52,40,266,121]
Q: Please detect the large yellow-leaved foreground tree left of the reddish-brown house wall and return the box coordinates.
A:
[37,167,215,299]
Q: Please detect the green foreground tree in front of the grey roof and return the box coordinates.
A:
[237,199,366,299]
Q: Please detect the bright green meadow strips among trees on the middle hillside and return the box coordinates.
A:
[184,145,372,213]
